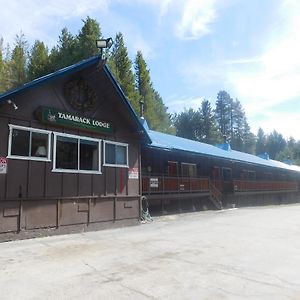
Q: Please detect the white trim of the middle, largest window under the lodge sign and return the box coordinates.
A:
[52,132,102,174]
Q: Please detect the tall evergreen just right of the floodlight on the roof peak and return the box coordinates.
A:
[108,32,140,114]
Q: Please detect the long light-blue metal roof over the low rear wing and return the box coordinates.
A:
[144,126,300,172]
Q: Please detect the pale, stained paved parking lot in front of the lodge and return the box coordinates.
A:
[0,204,300,300]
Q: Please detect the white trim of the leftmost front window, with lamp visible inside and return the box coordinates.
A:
[7,124,52,162]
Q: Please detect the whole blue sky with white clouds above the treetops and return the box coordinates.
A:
[0,0,300,139]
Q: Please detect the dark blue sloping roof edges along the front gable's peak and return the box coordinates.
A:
[0,55,150,142]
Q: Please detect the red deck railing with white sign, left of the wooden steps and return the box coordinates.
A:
[142,175,209,194]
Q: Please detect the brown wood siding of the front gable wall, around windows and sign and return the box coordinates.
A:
[0,64,145,233]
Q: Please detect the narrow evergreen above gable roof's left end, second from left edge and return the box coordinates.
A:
[10,33,28,87]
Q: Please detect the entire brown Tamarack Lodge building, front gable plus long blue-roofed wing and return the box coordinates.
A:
[0,56,300,240]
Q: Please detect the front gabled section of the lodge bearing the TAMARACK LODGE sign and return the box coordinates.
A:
[0,57,149,233]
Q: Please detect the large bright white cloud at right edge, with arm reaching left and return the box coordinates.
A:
[178,0,300,138]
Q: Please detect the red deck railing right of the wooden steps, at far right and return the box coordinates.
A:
[233,180,298,192]
